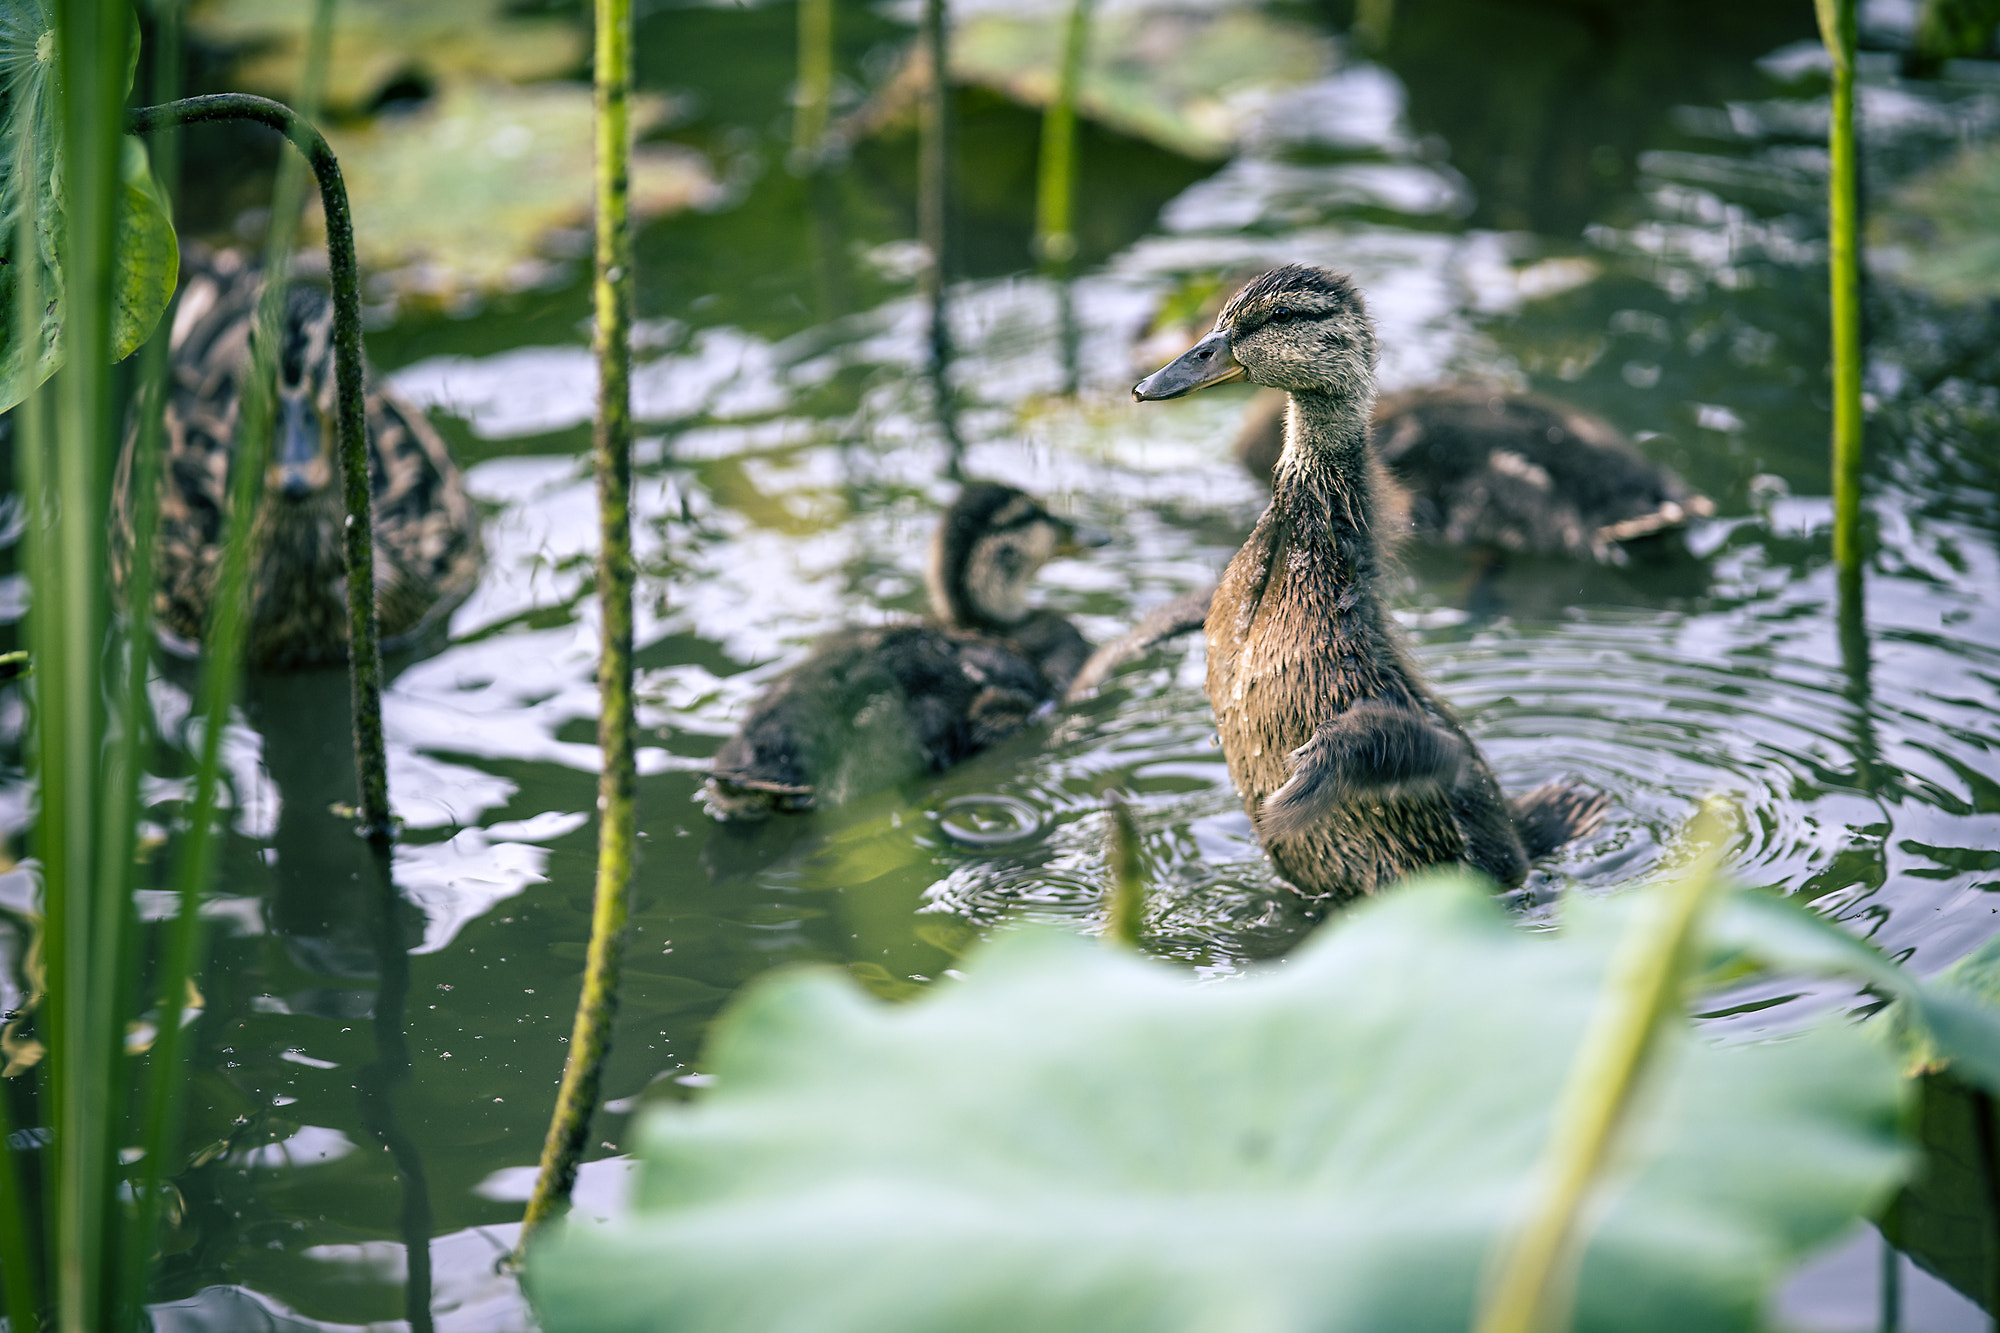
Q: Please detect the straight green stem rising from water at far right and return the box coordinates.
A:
[1814,0,1862,572]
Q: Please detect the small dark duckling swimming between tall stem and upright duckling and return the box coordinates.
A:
[708,482,1090,819]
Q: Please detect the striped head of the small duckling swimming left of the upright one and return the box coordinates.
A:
[926,482,1078,630]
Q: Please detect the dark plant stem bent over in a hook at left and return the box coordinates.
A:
[126,92,394,847]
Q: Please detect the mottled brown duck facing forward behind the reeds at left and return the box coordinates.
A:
[112,246,484,669]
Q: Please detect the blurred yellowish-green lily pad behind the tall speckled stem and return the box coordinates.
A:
[308,82,716,302]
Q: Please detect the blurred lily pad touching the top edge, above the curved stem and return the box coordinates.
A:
[188,0,588,112]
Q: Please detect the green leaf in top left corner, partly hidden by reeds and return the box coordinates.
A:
[0,0,180,410]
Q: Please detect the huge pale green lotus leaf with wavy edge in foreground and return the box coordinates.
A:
[528,879,1906,1333]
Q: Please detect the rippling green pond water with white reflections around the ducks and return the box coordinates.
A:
[0,2,2000,1329]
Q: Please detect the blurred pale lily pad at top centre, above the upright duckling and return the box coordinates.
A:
[952,8,1334,158]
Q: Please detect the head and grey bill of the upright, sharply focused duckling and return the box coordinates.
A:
[1132,264,1376,402]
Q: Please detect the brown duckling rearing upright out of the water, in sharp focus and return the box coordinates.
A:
[1132,264,1604,897]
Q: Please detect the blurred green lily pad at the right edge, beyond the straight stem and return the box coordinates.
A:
[1868,144,2000,302]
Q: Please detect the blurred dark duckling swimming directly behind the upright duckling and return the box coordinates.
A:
[1234,384,1716,564]
